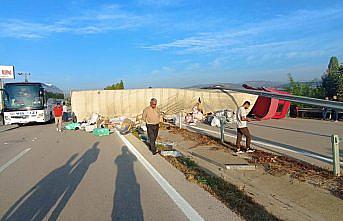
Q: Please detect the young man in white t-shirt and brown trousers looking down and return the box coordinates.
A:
[236,101,255,153]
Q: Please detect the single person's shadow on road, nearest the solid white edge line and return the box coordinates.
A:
[112,146,144,221]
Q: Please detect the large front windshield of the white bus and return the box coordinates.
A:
[4,85,44,110]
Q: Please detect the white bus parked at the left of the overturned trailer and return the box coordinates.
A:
[2,83,64,125]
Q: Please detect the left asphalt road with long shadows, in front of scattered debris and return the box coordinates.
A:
[0,125,240,220]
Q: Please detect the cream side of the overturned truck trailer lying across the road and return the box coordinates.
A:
[71,88,257,120]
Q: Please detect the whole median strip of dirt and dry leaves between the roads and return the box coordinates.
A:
[153,126,343,220]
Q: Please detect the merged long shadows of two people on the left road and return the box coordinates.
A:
[1,142,100,221]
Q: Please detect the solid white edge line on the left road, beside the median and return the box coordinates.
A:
[116,131,204,221]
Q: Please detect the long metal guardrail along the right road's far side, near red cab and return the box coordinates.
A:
[200,85,343,110]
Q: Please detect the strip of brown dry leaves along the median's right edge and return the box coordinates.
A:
[164,126,343,199]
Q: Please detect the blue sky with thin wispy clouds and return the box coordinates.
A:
[0,0,343,91]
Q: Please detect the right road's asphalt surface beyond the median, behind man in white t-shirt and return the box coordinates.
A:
[189,118,343,167]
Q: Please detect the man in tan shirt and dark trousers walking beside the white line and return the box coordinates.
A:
[143,98,161,155]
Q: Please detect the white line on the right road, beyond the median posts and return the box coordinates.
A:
[185,125,343,165]
